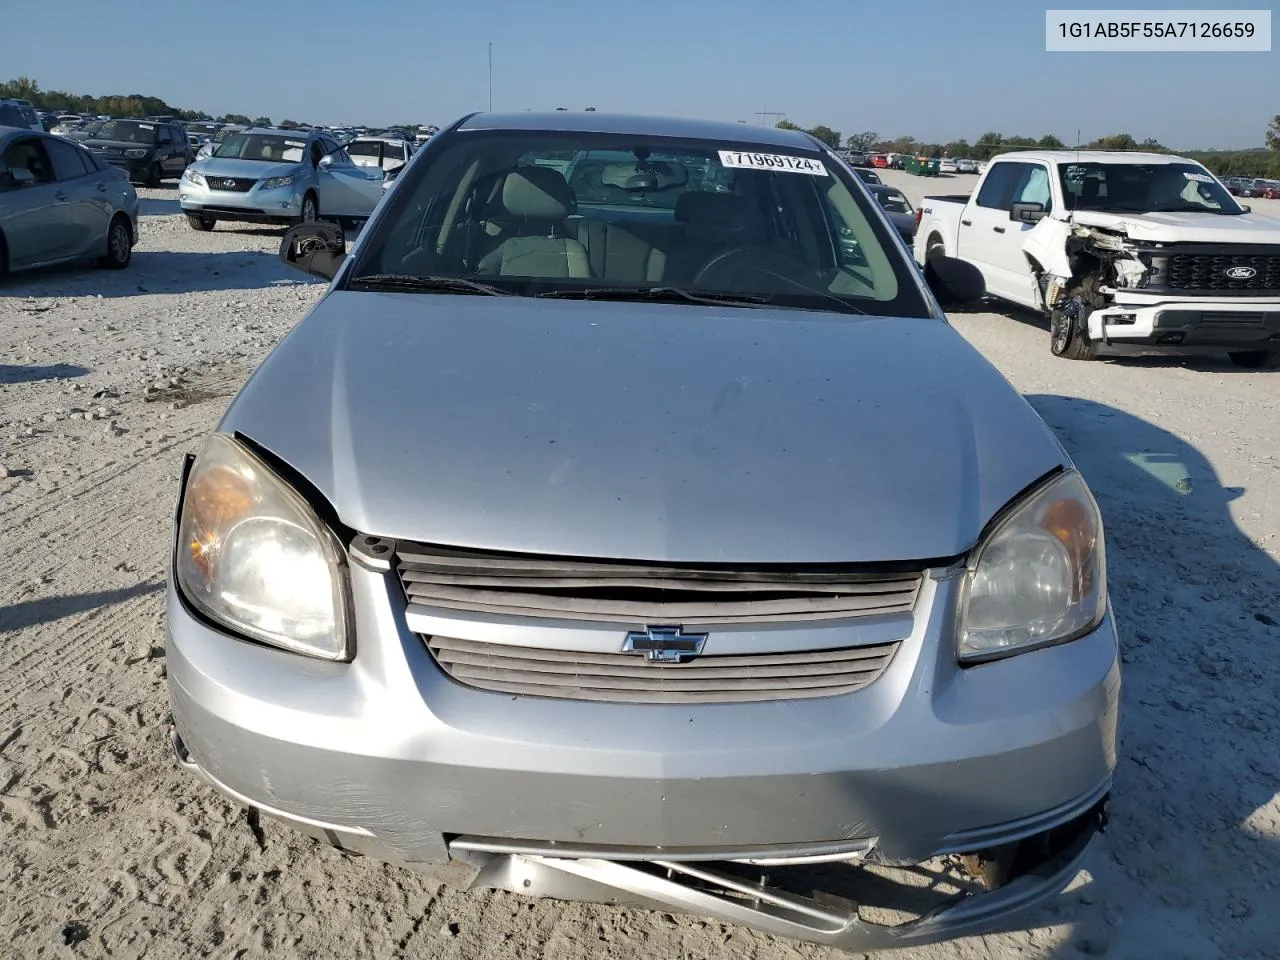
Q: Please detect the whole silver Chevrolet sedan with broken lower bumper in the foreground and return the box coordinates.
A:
[168,113,1120,951]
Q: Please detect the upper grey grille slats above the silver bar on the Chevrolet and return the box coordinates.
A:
[397,543,922,627]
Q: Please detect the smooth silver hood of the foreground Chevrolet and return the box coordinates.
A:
[220,292,1068,563]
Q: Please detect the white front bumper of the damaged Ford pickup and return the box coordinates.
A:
[1089,292,1280,349]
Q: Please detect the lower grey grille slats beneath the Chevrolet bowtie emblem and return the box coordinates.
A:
[426,636,899,704]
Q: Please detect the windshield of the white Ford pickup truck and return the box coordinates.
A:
[1059,163,1244,214]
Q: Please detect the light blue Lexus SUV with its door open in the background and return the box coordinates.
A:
[178,128,384,230]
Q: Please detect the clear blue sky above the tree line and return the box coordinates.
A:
[0,0,1280,148]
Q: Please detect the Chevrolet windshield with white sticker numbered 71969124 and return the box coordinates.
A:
[348,132,929,316]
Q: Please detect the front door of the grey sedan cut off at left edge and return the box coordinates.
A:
[0,137,73,269]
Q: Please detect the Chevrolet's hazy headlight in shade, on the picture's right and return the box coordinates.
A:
[957,470,1107,663]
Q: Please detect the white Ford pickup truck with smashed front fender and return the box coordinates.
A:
[915,150,1280,367]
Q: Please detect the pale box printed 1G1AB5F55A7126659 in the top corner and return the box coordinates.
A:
[1044,10,1271,54]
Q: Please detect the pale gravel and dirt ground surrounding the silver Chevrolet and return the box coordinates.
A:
[0,180,1280,960]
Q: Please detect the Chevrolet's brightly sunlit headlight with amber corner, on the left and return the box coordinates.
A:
[175,434,349,660]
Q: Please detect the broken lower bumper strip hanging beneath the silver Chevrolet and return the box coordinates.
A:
[170,731,1111,952]
